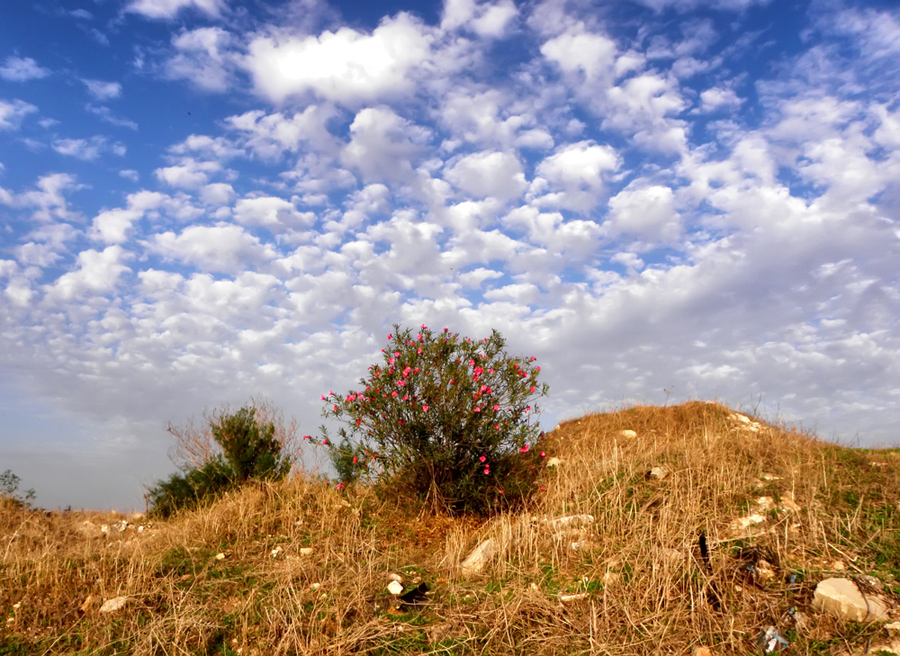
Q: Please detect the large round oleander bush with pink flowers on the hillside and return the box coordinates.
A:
[316,325,548,514]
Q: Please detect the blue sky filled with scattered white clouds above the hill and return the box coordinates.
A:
[0,0,900,510]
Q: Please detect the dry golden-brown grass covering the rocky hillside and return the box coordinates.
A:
[0,402,900,656]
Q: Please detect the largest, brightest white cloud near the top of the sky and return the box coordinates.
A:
[244,14,432,106]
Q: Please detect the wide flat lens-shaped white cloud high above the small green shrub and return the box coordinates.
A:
[149,223,275,273]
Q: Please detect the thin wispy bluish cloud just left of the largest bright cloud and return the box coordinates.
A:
[163,27,233,92]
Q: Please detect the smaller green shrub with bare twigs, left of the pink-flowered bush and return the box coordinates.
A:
[147,403,292,517]
